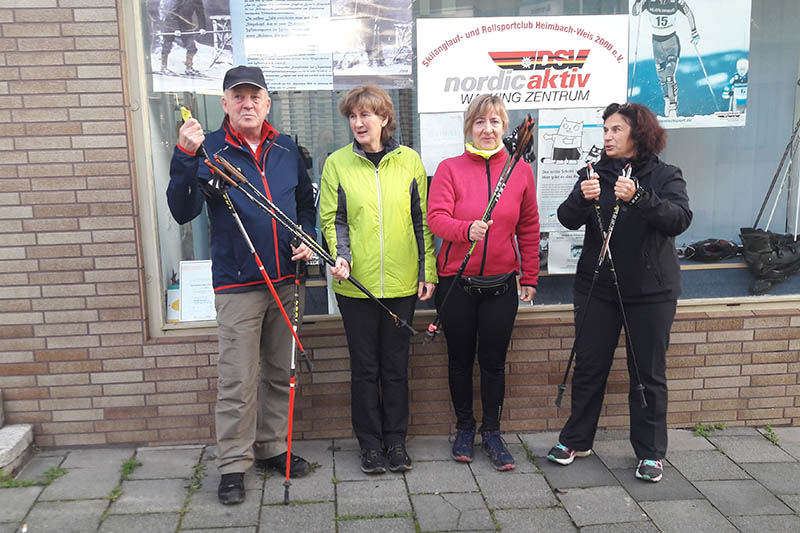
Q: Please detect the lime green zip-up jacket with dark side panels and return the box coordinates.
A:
[319,139,438,298]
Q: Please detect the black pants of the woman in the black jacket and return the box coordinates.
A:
[559,293,676,459]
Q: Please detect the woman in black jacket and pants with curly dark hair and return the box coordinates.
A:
[548,104,692,482]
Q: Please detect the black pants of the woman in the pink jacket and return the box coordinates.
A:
[435,276,519,431]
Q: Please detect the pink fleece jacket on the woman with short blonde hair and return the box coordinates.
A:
[428,145,539,287]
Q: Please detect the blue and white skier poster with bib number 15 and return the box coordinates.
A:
[628,0,751,128]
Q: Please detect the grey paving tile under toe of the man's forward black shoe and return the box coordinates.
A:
[181,490,260,531]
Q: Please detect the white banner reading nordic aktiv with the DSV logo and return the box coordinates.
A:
[417,15,628,113]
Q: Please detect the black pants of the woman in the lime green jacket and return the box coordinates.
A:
[336,294,417,450]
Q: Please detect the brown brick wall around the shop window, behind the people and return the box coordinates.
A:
[0,0,800,446]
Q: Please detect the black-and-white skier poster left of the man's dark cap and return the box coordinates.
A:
[147,0,233,94]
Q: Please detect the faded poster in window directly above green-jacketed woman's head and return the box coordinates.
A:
[330,0,414,89]
